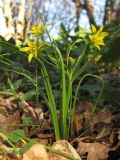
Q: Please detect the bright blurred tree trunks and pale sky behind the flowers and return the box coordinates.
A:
[0,0,120,40]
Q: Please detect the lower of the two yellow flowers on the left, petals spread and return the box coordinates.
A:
[20,38,45,63]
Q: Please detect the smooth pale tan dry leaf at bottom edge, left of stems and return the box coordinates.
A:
[23,144,49,160]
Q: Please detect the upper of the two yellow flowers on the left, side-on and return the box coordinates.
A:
[27,21,47,37]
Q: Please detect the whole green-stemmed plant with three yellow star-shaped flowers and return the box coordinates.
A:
[20,22,108,140]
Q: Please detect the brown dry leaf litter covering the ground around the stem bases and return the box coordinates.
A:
[0,97,120,160]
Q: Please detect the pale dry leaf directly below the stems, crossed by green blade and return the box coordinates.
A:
[49,140,81,160]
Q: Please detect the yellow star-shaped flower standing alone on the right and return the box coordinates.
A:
[89,25,108,50]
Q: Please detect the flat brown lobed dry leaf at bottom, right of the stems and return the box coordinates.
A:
[77,142,109,160]
